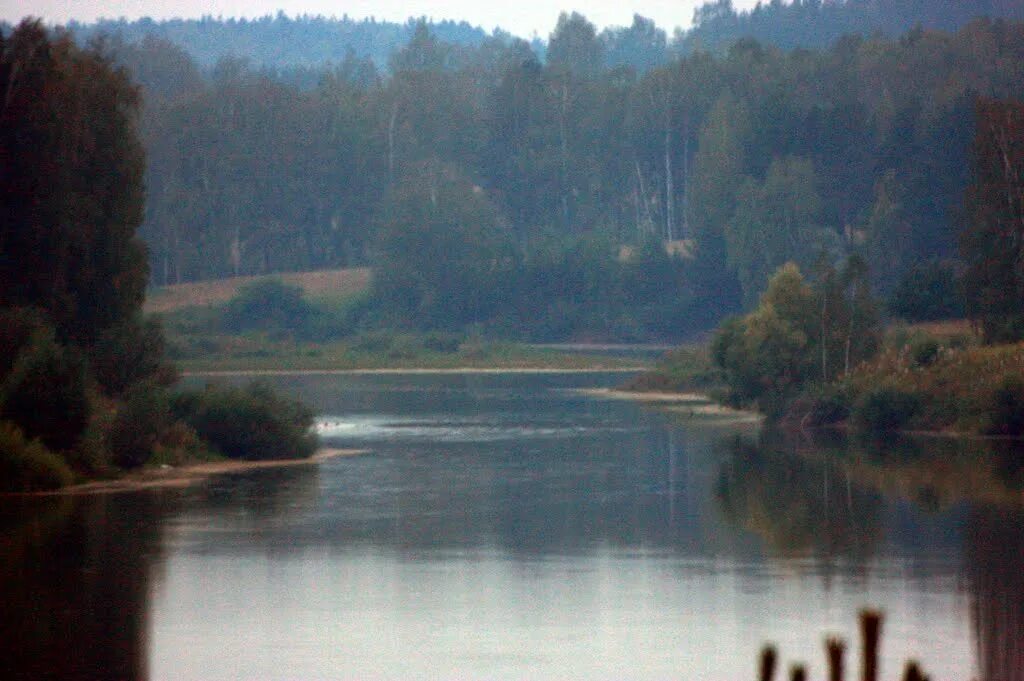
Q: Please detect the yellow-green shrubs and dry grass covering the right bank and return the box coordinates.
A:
[624,267,1024,438]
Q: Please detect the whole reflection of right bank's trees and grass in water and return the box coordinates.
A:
[718,432,1024,681]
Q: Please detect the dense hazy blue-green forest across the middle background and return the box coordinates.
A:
[101,13,1024,337]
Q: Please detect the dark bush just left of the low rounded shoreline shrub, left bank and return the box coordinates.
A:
[108,384,170,468]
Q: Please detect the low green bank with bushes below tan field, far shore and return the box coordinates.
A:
[158,276,646,372]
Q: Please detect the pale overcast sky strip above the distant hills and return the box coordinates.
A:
[0,0,757,38]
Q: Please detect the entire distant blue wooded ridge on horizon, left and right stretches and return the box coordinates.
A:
[49,0,1024,71]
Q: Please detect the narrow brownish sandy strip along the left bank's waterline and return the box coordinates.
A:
[11,449,369,497]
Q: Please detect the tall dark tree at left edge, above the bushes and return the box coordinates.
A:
[0,19,147,346]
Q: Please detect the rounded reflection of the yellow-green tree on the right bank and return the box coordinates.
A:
[717,435,883,562]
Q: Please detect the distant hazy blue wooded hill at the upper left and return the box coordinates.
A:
[67,12,489,68]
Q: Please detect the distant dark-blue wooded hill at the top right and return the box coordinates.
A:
[673,0,1024,53]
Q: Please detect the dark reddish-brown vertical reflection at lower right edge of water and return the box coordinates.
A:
[965,508,1024,681]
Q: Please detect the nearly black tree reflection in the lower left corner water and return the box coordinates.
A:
[0,495,174,679]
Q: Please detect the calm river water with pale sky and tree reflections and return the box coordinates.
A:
[0,375,1024,681]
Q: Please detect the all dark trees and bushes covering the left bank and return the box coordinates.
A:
[0,22,316,492]
